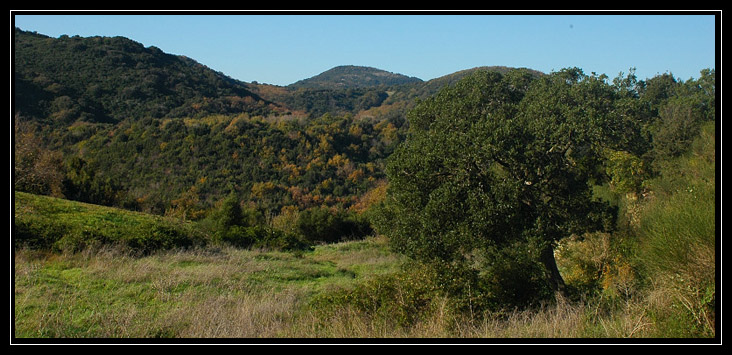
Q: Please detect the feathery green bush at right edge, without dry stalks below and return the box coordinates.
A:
[640,123,717,284]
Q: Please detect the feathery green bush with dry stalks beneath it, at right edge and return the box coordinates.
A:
[638,122,717,337]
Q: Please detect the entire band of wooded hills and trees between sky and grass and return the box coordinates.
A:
[12,29,718,336]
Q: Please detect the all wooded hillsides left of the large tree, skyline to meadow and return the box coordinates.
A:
[13,29,548,218]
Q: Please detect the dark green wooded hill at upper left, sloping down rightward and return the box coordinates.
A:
[13,28,284,126]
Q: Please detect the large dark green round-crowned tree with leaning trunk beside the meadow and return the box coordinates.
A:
[376,69,630,302]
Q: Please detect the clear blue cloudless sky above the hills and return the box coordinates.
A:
[12,12,721,85]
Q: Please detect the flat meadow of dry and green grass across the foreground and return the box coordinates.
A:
[14,234,704,342]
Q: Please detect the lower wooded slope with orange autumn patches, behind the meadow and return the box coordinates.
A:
[50,115,399,218]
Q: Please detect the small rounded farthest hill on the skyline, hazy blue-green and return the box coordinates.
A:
[288,65,422,89]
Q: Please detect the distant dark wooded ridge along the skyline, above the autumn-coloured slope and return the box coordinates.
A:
[12,28,548,126]
